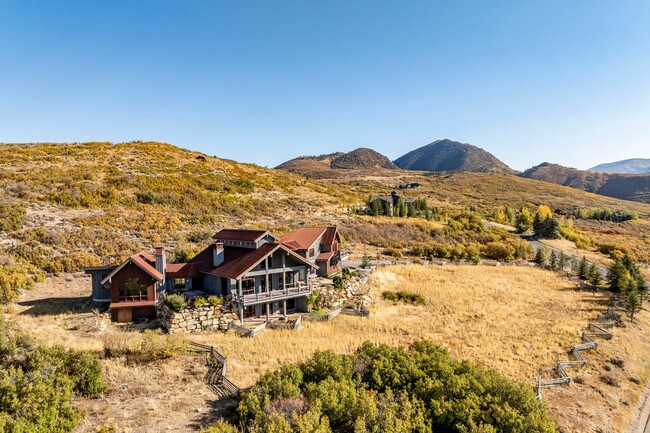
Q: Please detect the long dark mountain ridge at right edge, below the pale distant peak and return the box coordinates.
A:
[521,162,650,203]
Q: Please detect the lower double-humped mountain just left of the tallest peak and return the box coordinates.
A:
[276,147,397,178]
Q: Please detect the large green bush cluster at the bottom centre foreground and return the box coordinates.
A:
[208,341,555,433]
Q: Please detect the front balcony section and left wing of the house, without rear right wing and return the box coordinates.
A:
[86,229,318,322]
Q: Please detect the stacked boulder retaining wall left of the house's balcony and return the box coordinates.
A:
[158,305,236,334]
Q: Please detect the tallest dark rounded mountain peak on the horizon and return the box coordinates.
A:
[393,139,514,173]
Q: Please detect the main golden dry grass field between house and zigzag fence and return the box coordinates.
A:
[192,265,606,386]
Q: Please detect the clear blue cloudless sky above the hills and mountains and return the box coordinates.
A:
[0,0,650,169]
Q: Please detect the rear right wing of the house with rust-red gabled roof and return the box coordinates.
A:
[280,226,341,275]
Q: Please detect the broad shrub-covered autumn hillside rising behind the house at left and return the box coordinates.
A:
[0,142,358,269]
